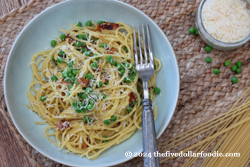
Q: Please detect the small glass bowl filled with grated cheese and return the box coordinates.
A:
[195,0,250,50]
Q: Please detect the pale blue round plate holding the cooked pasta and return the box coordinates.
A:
[4,0,179,166]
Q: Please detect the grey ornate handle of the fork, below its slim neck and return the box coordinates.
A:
[142,99,159,167]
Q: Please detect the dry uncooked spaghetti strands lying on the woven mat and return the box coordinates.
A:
[160,88,250,167]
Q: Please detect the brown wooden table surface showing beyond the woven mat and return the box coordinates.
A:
[0,0,32,167]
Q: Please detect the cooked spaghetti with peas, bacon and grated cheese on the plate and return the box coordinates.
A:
[27,22,161,159]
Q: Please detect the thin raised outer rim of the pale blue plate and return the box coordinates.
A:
[3,0,180,167]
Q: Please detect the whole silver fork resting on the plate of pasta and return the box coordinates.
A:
[133,24,159,167]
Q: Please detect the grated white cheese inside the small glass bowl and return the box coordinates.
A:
[201,0,250,43]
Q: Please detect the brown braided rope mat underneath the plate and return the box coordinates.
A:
[0,0,250,167]
